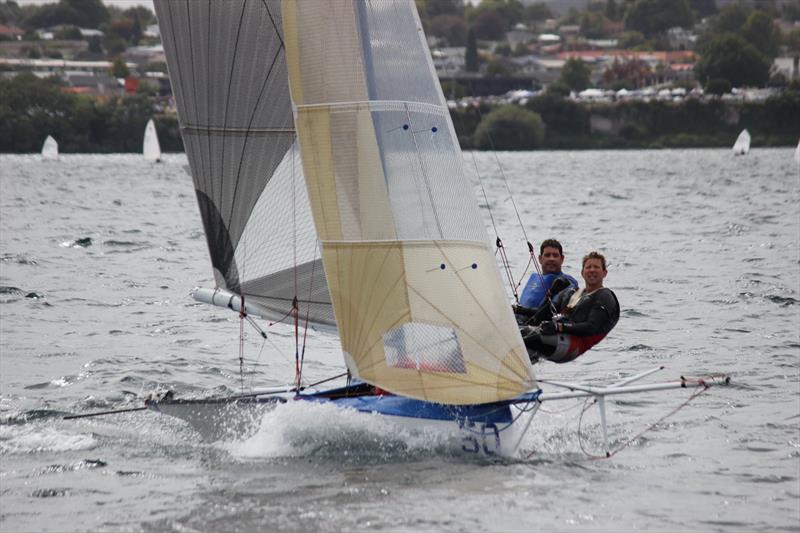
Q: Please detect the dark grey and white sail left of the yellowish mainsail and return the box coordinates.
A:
[155,0,334,324]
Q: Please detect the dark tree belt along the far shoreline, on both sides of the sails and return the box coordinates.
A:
[0,73,800,153]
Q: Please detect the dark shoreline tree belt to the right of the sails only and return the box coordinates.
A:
[451,83,800,150]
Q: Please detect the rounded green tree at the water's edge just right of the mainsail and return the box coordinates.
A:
[474,105,544,150]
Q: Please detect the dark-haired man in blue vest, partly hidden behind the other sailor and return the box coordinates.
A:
[514,239,578,324]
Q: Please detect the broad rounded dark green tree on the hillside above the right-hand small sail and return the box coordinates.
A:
[694,33,770,87]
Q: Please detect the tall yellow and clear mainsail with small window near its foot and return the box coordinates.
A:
[282,0,535,404]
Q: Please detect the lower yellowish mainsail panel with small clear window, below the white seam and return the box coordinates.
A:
[322,241,535,404]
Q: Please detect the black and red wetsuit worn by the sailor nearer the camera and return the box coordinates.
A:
[521,287,619,363]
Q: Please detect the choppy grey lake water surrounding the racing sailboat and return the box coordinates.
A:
[0,148,800,533]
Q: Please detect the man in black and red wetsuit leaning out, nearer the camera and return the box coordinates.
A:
[520,252,619,363]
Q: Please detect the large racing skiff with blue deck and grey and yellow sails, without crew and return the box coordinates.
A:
[117,0,724,453]
